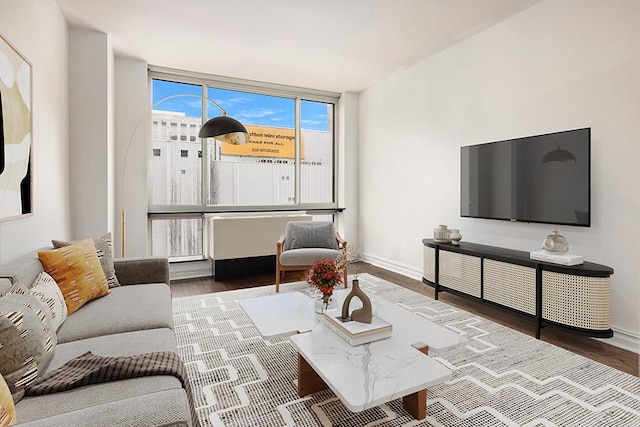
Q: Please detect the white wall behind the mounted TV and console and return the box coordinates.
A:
[360,0,640,351]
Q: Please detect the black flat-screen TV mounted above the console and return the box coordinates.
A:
[460,128,591,227]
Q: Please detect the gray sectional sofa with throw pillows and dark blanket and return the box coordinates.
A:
[0,248,192,427]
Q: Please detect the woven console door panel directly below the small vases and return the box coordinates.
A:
[439,251,481,298]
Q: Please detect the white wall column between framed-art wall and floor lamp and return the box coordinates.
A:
[69,28,114,239]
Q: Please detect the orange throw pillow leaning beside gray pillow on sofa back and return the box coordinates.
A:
[38,238,110,315]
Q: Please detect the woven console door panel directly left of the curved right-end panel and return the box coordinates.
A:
[483,259,536,316]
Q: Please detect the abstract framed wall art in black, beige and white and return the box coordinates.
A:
[0,35,33,221]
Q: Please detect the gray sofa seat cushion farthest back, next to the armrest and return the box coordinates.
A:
[58,283,173,344]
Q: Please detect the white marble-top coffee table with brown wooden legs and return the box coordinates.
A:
[239,289,466,419]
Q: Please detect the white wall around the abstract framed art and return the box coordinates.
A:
[0,0,70,264]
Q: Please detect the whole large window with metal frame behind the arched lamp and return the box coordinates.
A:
[149,71,338,258]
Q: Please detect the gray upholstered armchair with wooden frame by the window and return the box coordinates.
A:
[276,221,347,292]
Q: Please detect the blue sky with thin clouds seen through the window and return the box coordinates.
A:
[153,80,328,131]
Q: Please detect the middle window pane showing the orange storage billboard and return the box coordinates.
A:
[207,87,298,207]
